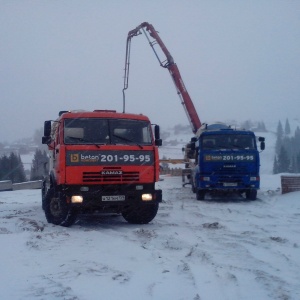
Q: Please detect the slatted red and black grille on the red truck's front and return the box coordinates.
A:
[82,172,140,183]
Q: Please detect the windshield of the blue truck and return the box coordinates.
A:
[202,134,255,150]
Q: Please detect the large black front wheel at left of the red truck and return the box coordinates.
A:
[45,188,77,227]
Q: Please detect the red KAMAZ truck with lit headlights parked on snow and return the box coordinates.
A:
[42,110,162,226]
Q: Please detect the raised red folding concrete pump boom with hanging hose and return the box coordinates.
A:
[123,22,201,133]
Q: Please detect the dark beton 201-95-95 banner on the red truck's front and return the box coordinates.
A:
[66,151,153,166]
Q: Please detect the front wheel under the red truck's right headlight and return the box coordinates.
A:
[122,203,158,224]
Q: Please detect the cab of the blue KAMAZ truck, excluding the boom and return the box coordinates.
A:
[191,124,265,200]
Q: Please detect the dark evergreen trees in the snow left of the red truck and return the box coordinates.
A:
[0,149,48,183]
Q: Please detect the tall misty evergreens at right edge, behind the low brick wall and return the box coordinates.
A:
[273,119,300,174]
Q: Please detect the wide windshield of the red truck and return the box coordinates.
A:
[64,118,152,146]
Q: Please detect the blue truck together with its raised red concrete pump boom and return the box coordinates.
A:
[123,22,265,200]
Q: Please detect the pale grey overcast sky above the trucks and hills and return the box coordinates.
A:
[0,0,300,142]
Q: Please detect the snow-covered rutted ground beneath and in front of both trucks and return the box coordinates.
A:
[0,176,300,300]
